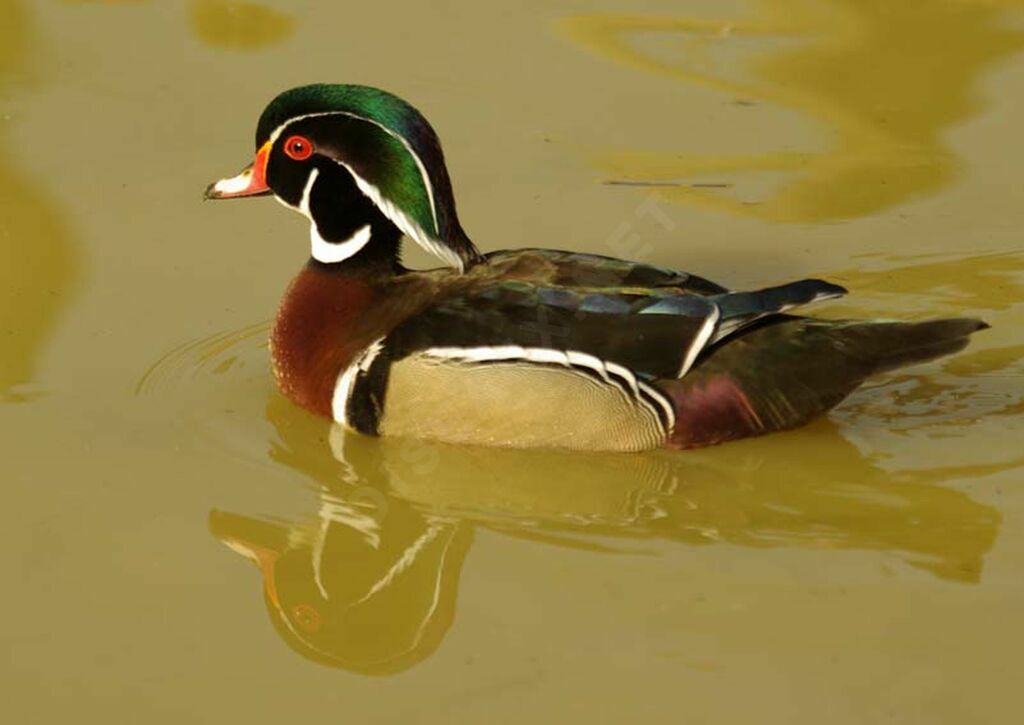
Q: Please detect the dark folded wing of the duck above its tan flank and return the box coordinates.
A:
[386,280,846,378]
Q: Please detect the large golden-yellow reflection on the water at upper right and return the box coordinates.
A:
[563,0,1024,222]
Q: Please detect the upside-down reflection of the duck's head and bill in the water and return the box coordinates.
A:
[210,500,471,675]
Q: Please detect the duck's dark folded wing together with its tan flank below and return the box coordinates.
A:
[334,280,841,451]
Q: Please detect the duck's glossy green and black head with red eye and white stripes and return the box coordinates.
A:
[205,84,481,269]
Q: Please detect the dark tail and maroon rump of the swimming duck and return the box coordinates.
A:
[658,317,988,447]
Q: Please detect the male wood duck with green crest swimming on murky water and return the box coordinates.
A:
[205,85,987,451]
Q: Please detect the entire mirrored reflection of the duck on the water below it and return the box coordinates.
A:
[210,394,999,675]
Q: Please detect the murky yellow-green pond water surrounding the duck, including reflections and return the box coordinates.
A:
[0,0,1024,725]
